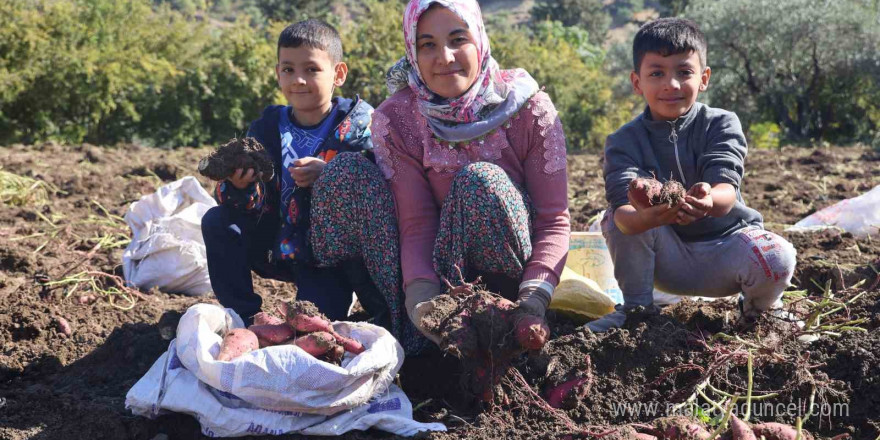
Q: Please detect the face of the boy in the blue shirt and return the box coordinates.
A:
[275,46,348,114]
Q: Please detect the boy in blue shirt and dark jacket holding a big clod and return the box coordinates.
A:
[202,20,388,325]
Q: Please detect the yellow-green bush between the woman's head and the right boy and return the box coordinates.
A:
[489,23,634,150]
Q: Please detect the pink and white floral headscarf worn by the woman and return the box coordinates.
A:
[386,0,538,142]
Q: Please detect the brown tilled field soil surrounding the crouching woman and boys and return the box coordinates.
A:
[0,144,880,440]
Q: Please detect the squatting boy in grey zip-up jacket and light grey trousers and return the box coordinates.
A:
[587,18,795,332]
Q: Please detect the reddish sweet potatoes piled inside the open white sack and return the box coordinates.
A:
[217,301,364,365]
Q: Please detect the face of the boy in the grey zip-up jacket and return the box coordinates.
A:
[630,51,712,121]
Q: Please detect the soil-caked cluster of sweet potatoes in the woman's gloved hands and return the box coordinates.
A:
[422,284,550,401]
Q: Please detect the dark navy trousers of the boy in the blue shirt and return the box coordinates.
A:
[202,206,390,328]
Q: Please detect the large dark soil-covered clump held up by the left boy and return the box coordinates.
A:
[199,137,275,182]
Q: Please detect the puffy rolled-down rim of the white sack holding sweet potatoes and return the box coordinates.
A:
[177,304,404,415]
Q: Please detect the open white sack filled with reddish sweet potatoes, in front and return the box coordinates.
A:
[126,303,445,436]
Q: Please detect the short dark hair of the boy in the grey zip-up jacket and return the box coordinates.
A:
[633,18,707,73]
